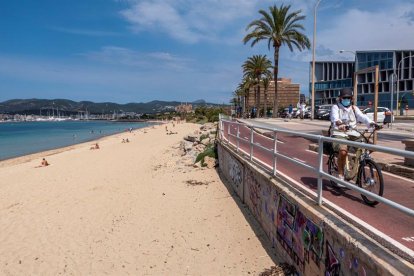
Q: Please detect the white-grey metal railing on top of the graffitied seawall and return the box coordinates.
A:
[219,117,414,217]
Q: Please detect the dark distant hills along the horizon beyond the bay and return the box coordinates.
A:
[0,99,222,115]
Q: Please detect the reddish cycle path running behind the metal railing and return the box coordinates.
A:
[224,119,414,253]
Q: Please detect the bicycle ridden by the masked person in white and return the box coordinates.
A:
[328,125,384,206]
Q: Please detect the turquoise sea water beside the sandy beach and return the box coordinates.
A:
[0,121,151,160]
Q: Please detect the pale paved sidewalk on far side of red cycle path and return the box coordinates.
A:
[239,118,414,179]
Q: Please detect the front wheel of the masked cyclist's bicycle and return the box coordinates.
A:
[357,160,384,206]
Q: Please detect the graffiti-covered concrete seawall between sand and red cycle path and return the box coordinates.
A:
[218,143,414,275]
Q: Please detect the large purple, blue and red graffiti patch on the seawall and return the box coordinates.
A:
[277,196,323,271]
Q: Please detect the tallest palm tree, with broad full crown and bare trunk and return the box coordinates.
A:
[243,4,310,117]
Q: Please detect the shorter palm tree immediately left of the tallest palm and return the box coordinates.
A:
[242,55,272,116]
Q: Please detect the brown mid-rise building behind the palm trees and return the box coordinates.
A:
[246,78,300,113]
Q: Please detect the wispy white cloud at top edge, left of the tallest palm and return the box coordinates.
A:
[120,0,272,43]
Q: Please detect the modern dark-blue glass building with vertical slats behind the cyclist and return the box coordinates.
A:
[309,50,414,110]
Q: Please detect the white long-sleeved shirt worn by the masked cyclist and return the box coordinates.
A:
[330,103,373,137]
